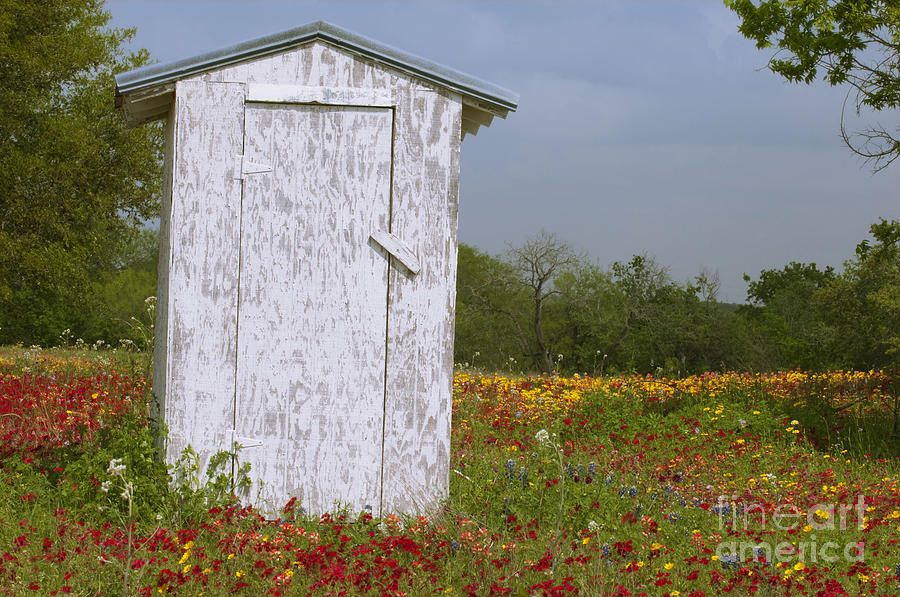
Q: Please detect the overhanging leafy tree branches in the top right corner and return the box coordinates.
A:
[725,0,900,171]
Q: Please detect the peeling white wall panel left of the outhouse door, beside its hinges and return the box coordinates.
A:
[165,79,244,468]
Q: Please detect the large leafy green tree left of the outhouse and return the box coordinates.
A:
[0,0,161,343]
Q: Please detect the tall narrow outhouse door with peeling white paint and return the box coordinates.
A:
[233,88,394,515]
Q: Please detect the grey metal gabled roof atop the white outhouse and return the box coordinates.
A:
[116,21,519,111]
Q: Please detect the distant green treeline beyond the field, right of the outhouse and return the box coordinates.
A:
[455,220,900,375]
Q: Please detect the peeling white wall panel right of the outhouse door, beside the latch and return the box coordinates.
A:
[382,81,461,513]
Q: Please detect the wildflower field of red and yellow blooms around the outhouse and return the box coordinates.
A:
[0,350,900,597]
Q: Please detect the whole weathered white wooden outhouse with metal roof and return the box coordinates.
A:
[116,22,517,515]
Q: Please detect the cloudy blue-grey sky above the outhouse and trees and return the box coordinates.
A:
[107,0,900,302]
